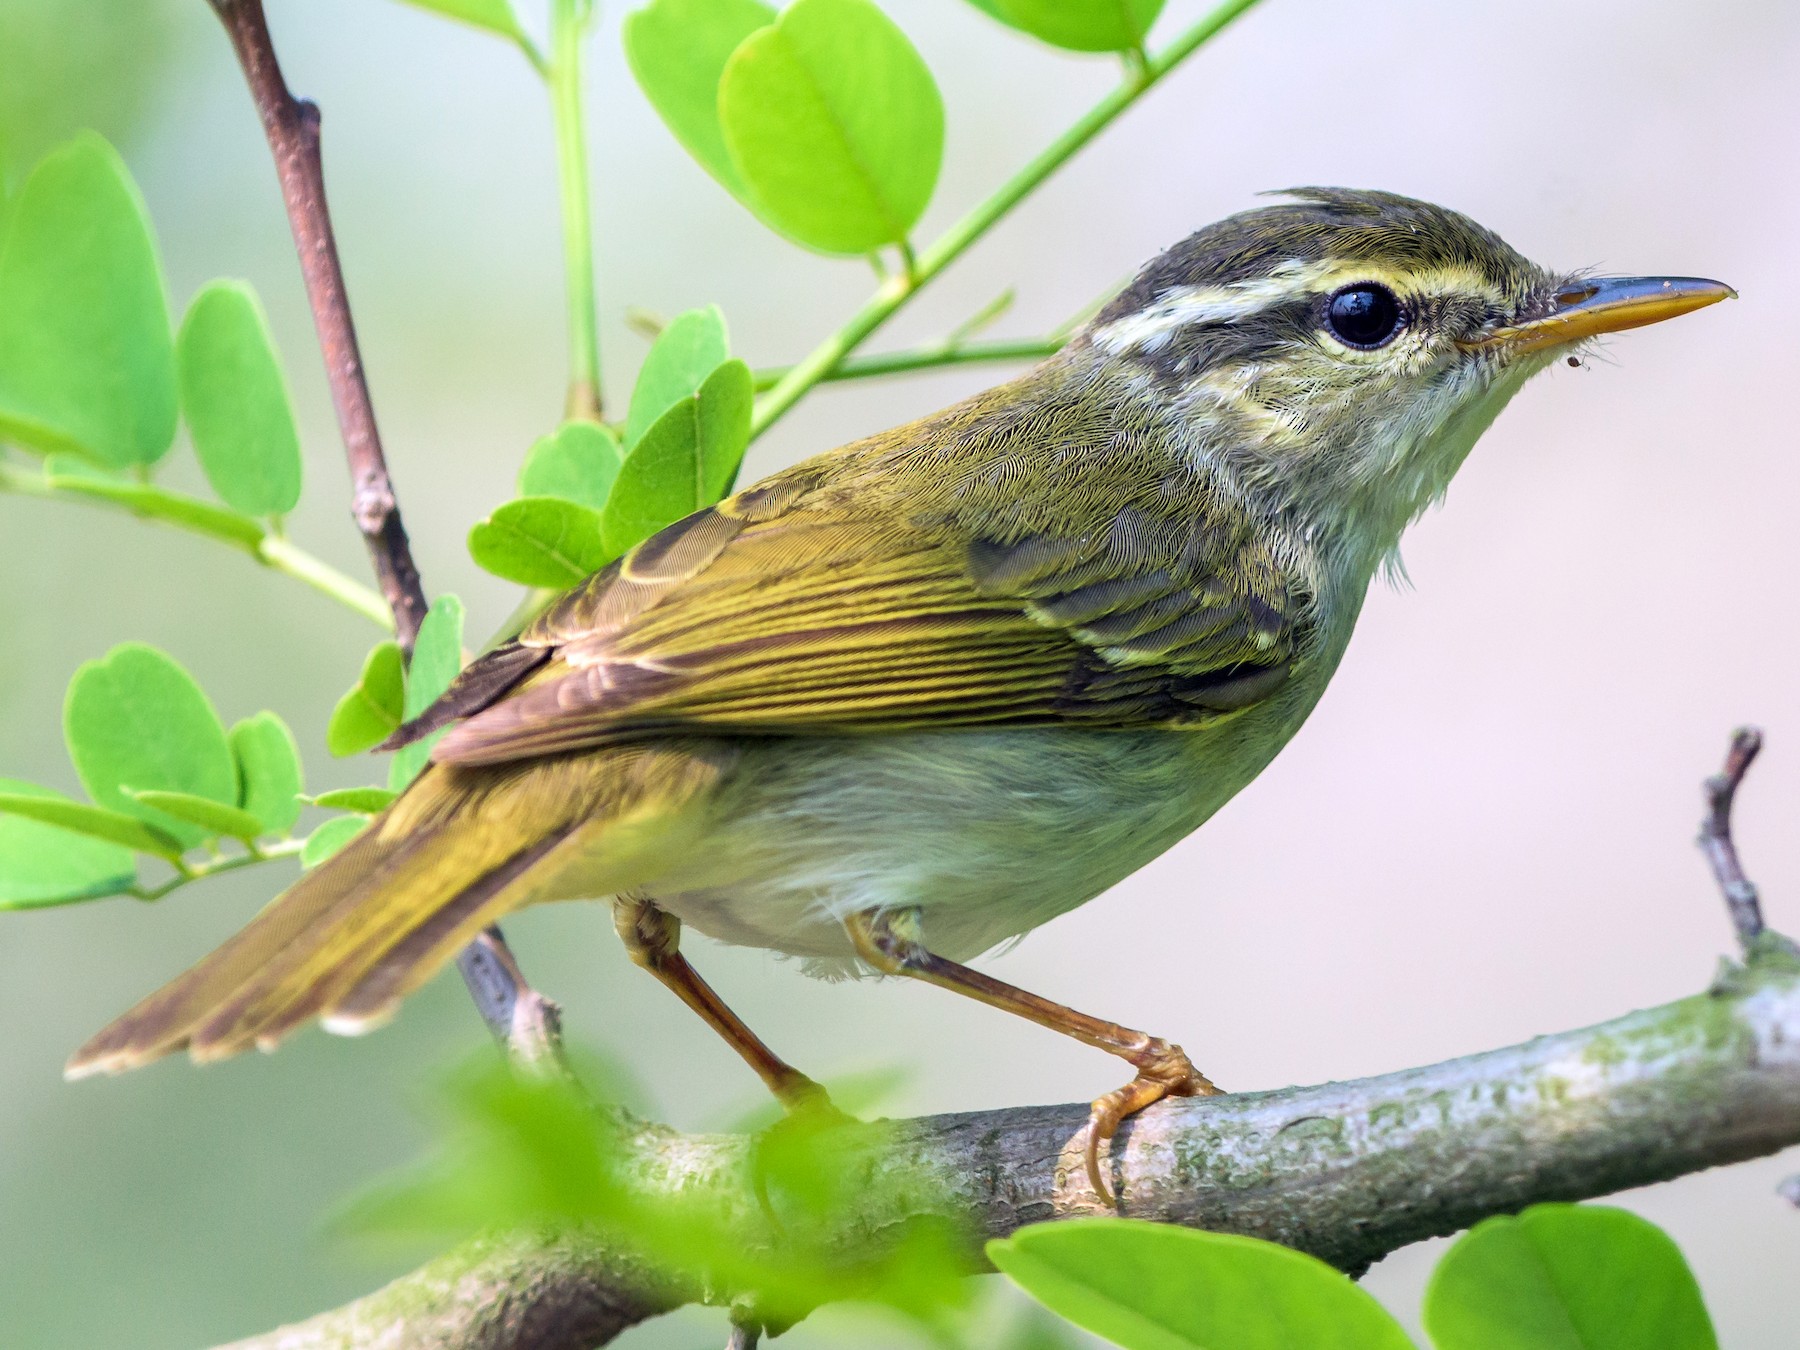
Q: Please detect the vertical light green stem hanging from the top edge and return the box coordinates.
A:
[547,0,601,421]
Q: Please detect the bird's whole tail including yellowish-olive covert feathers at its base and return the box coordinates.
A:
[67,743,734,1078]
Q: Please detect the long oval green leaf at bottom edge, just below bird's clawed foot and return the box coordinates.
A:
[988,1219,1413,1350]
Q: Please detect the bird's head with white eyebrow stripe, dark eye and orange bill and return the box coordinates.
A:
[1087,187,1733,558]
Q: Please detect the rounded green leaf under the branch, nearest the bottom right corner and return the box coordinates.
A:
[1426,1204,1719,1350]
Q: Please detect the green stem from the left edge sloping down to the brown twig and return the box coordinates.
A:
[0,463,394,632]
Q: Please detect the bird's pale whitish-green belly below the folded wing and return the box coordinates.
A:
[643,671,1328,972]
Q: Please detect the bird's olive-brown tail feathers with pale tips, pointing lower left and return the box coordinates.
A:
[67,767,619,1078]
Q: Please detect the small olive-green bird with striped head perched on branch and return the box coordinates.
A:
[68,187,1733,1195]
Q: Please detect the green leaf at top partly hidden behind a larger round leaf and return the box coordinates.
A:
[623,0,776,198]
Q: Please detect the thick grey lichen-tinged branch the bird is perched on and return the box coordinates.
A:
[221,932,1800,1350]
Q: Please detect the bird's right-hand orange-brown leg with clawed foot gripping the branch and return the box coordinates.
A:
[844,909,1219,1204]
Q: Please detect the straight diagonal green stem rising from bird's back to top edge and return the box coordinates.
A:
[751,0,1256,437]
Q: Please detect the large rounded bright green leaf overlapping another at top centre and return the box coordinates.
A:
[718,0,943,254]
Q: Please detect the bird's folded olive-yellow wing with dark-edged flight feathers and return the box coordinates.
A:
[418,423,1307,763]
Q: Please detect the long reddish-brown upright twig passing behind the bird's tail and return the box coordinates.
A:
[209,0,562,1066]
